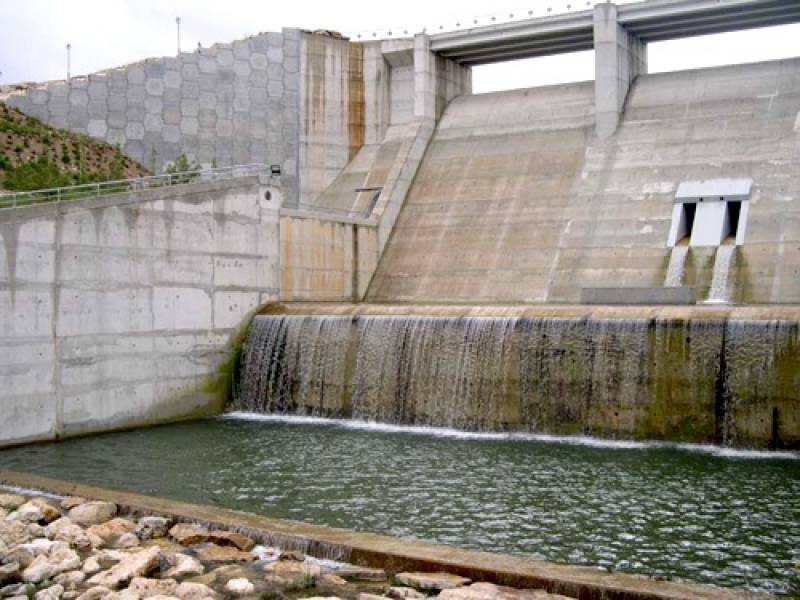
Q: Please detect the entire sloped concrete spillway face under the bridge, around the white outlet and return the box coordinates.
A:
[367,59,800,303]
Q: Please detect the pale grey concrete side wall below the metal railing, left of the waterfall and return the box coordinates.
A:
[0,177,281,445]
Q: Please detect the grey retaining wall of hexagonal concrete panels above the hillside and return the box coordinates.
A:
[8,29,300,201]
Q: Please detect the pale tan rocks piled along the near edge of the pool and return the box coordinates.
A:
[0,493,567,600]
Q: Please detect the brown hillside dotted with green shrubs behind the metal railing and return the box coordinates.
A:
[0,102,149,191]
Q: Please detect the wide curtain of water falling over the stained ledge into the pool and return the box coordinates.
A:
[235,315,800,446]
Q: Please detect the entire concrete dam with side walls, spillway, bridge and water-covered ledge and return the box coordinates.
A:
[0,0,800,449]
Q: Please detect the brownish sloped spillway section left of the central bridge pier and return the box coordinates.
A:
[368,84,593,302]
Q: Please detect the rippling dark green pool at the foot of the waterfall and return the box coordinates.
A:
[0,419,800,594]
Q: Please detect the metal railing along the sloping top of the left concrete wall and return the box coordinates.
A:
[0,163,270,210]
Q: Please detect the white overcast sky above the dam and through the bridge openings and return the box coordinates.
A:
[0,0,800,92]
